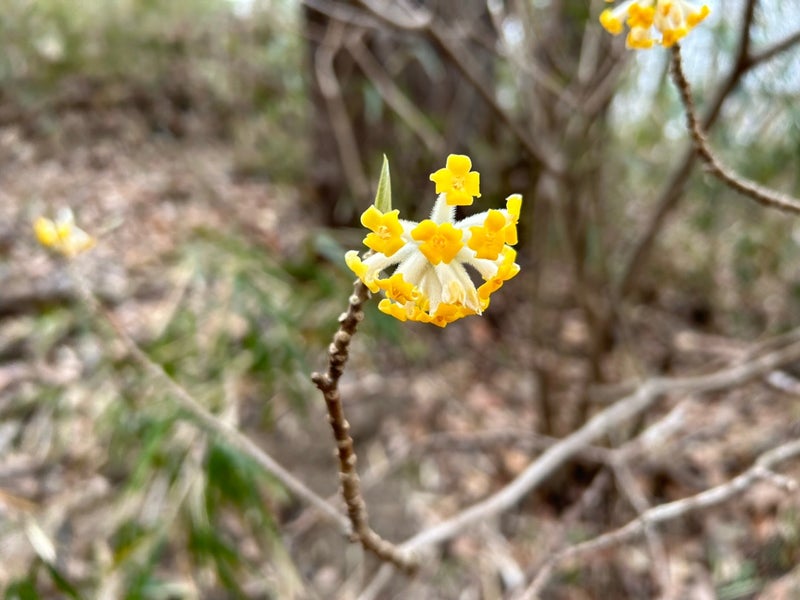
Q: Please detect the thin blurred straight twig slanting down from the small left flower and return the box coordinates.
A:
[64,265,350,535]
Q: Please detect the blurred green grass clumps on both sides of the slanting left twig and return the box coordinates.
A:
[98,232,343,598]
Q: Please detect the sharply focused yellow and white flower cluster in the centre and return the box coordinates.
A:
[345,154,522,327]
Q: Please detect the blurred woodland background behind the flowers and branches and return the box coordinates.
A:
[0,0,800,600]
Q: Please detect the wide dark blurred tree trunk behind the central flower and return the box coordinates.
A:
[304,0,496,225]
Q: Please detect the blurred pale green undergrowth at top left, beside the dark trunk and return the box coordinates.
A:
[0,0,307,181]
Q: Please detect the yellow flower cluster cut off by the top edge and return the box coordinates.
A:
[600,0,709,50]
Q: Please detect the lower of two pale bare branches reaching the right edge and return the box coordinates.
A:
[519,440,800,600]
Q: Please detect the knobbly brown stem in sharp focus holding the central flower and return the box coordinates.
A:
[311,281,418,573]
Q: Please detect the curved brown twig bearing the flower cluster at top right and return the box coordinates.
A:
[672,44,800,214]
